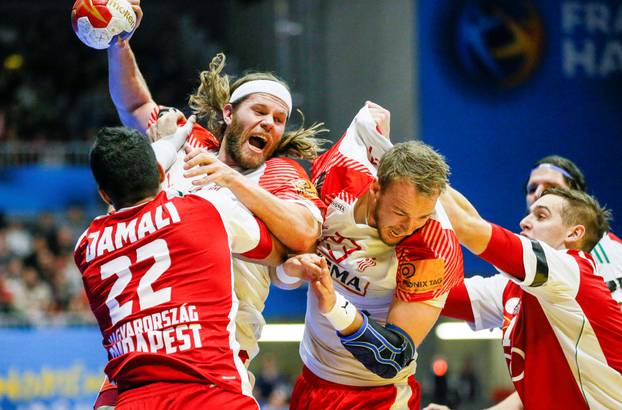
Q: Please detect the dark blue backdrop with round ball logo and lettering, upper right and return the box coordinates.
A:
[416,0,622,273]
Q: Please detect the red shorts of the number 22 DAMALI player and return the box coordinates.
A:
[115,383,259,410]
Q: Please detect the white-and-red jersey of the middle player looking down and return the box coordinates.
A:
[300,107,462,386]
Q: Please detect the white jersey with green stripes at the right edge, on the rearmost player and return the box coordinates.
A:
[592,232,622,304]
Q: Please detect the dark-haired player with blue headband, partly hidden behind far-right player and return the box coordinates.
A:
[525,155,622,309]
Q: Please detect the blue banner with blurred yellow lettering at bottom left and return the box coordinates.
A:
[0,327,107,410]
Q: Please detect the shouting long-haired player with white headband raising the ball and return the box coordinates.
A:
[99,0,324,404]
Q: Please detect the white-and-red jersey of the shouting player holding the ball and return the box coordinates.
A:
[150,107,324,359]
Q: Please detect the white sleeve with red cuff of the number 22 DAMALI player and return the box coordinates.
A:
[192,184,272,254]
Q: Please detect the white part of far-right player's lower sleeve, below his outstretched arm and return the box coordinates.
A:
[464,275,508,330]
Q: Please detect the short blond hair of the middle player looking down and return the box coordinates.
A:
[378,141,450,195]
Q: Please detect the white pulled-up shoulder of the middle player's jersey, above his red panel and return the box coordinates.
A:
[339,105,393,169]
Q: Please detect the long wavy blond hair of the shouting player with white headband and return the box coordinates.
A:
[188,53,328,160]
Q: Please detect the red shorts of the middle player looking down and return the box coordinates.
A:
[289,366,421,410]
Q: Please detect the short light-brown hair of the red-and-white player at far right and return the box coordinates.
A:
[541,188,611,252]
